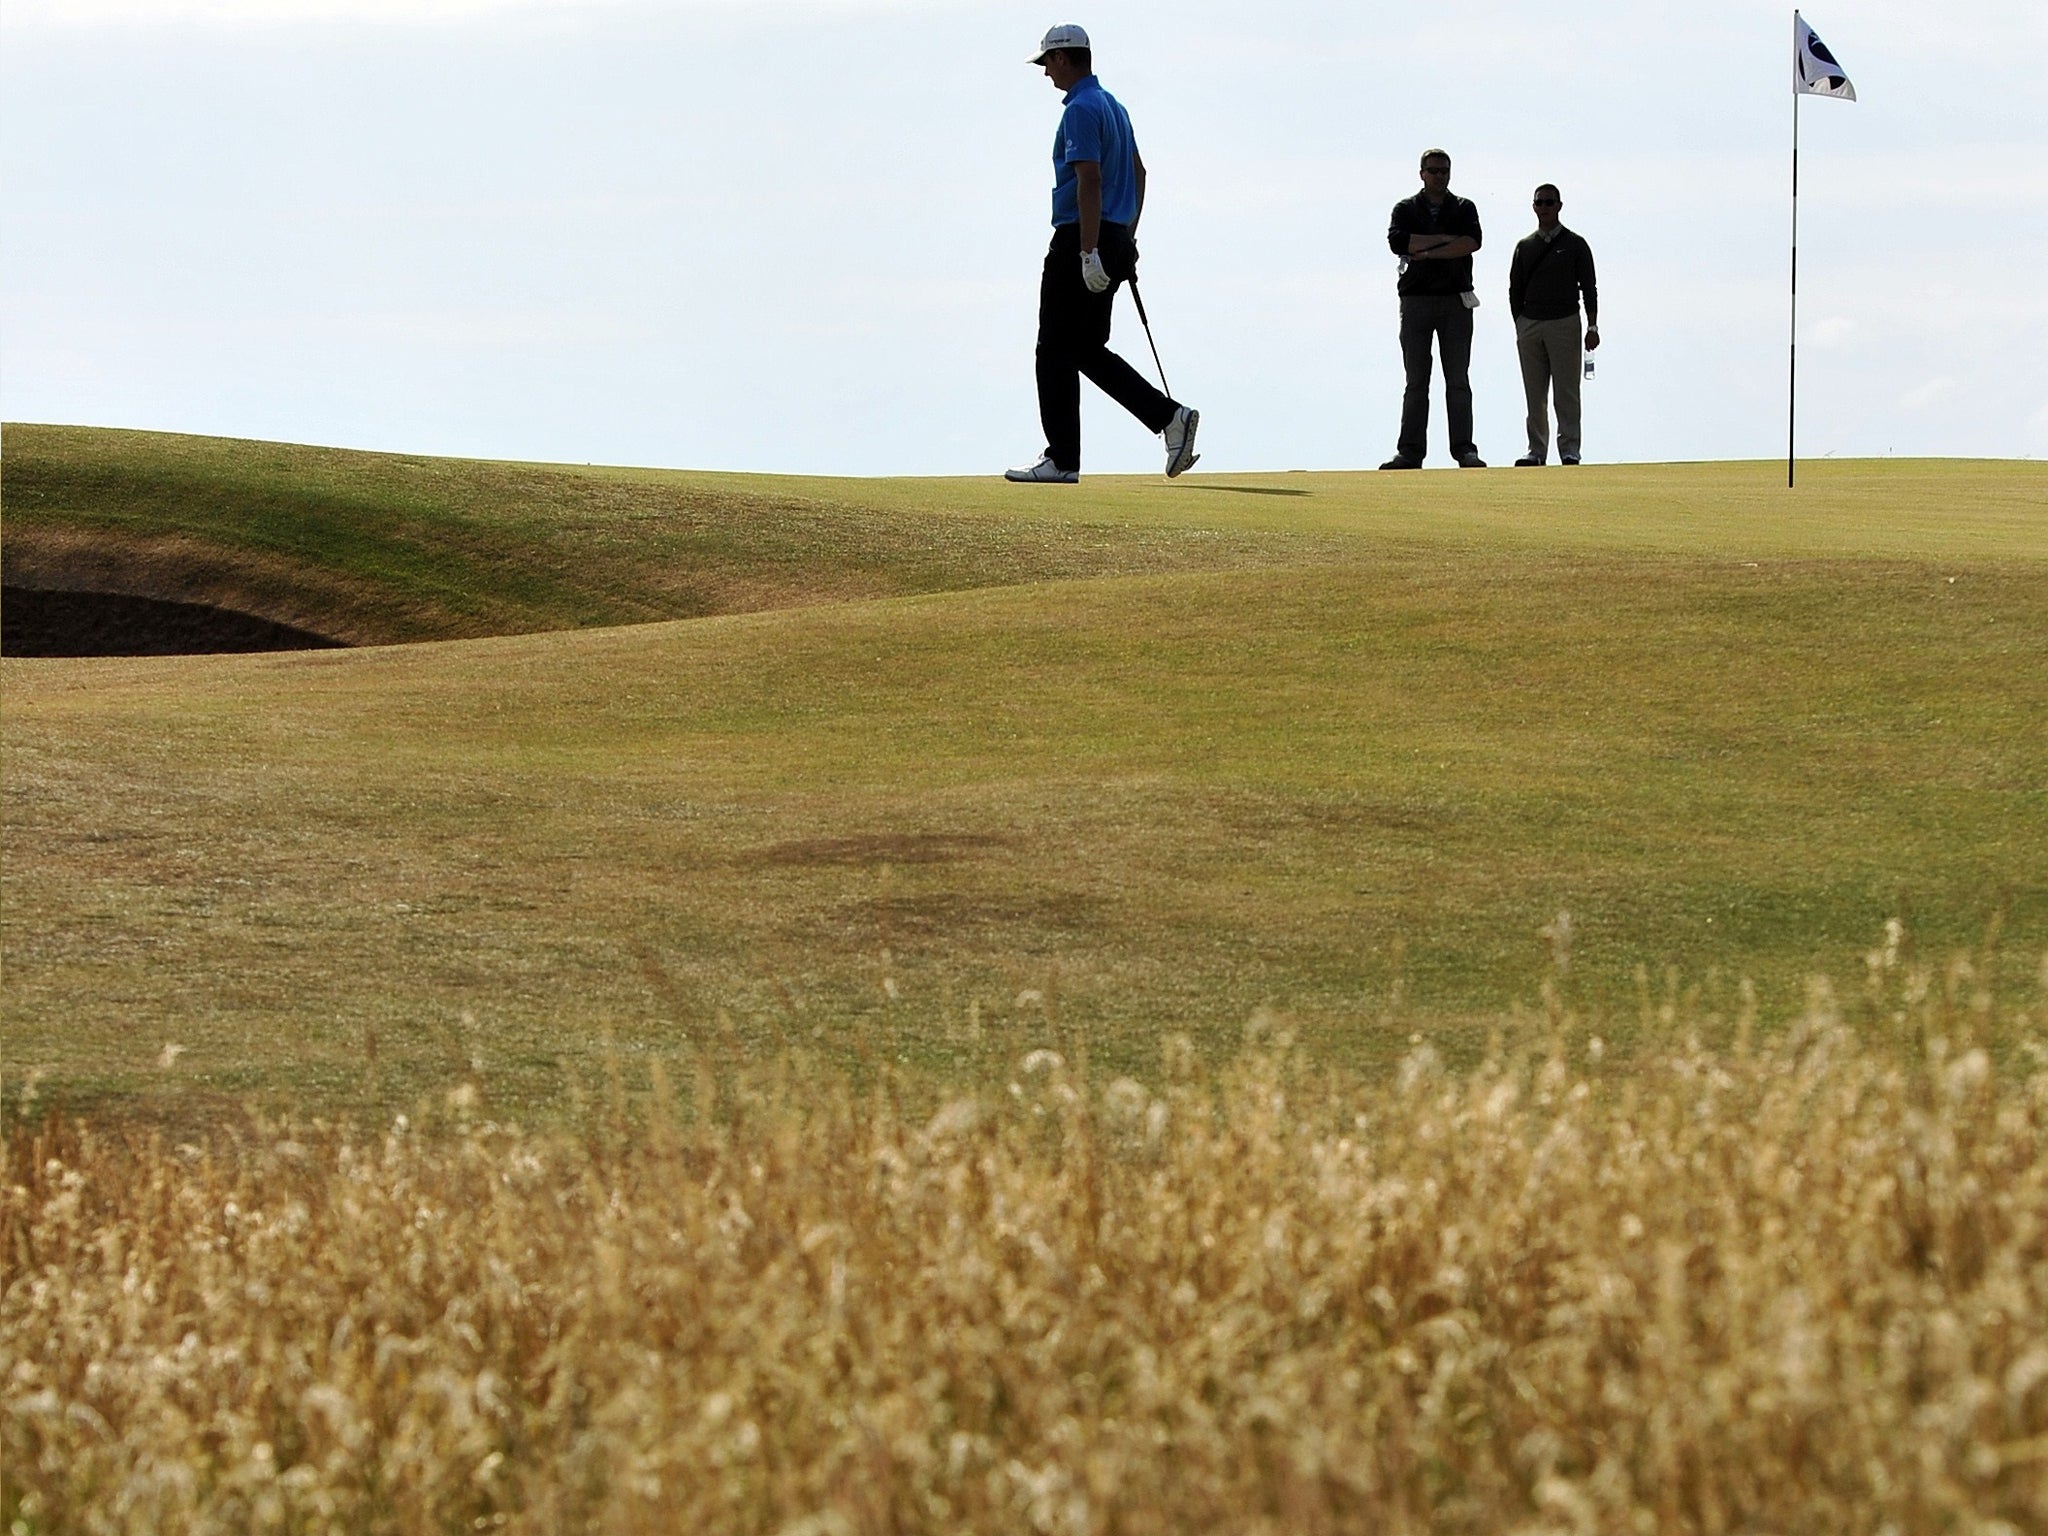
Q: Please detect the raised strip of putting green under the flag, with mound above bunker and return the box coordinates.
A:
[0,424,2048,645]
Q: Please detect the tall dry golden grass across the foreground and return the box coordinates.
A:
[0,966,2048,1536]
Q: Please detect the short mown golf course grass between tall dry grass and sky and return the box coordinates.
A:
[0,428,2048,1112]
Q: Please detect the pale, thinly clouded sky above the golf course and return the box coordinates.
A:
[0,0,2048,473]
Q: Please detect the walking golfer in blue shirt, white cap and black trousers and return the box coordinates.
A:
[1006,25,1200,485]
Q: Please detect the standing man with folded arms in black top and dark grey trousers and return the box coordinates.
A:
[1380,150,1487,469]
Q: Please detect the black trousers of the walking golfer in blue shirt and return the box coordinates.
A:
[1038,223,1180,471]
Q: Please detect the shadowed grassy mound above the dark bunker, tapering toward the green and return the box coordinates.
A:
[4,426,1376,645]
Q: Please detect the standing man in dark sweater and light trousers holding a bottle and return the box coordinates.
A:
[1507,182,1599,467]
